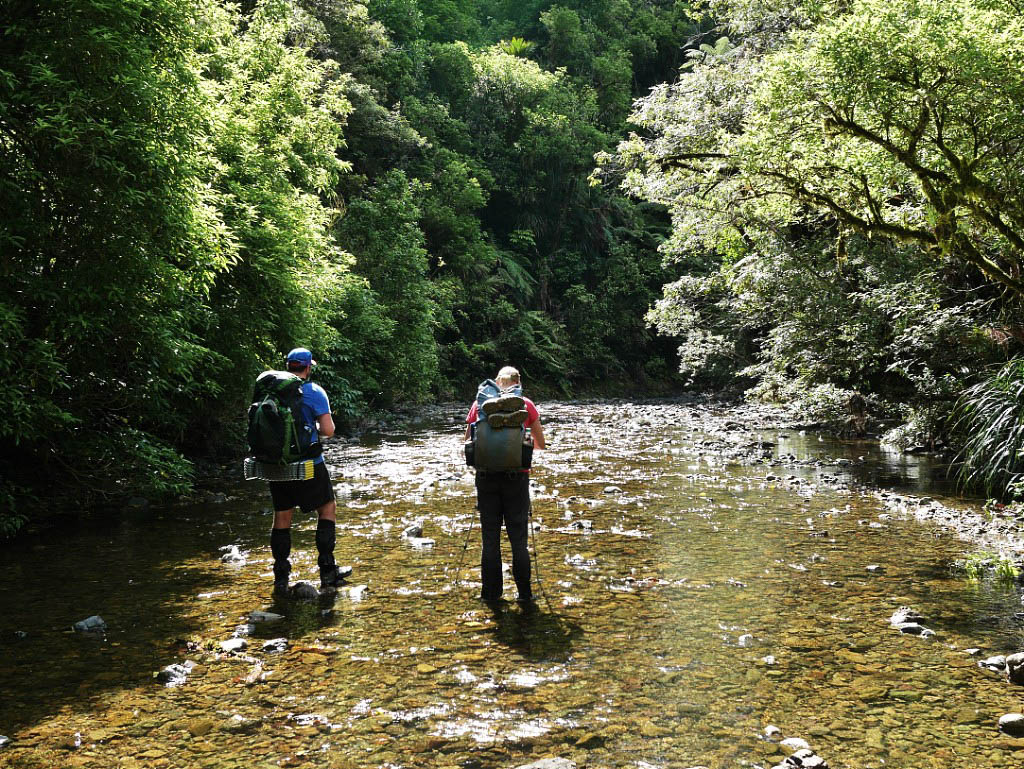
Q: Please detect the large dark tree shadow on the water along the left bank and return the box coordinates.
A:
[0,509,243,730]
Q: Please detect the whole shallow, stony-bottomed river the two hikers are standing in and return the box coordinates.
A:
[0,402,1024,769]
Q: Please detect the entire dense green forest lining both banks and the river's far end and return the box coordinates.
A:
[6,0,1024,530]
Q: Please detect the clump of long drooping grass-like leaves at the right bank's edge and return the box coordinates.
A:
[953,358,1024,496]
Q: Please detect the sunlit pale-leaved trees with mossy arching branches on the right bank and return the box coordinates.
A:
[599,0,1024,495]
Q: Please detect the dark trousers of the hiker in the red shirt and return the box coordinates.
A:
[476,472,534,600]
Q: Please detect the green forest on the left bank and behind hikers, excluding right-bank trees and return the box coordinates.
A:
[0,0,696,527]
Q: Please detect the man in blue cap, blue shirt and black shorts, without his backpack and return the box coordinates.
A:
[269,347,352,593]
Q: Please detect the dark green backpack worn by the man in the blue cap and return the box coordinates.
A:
[248,371,321,465]
